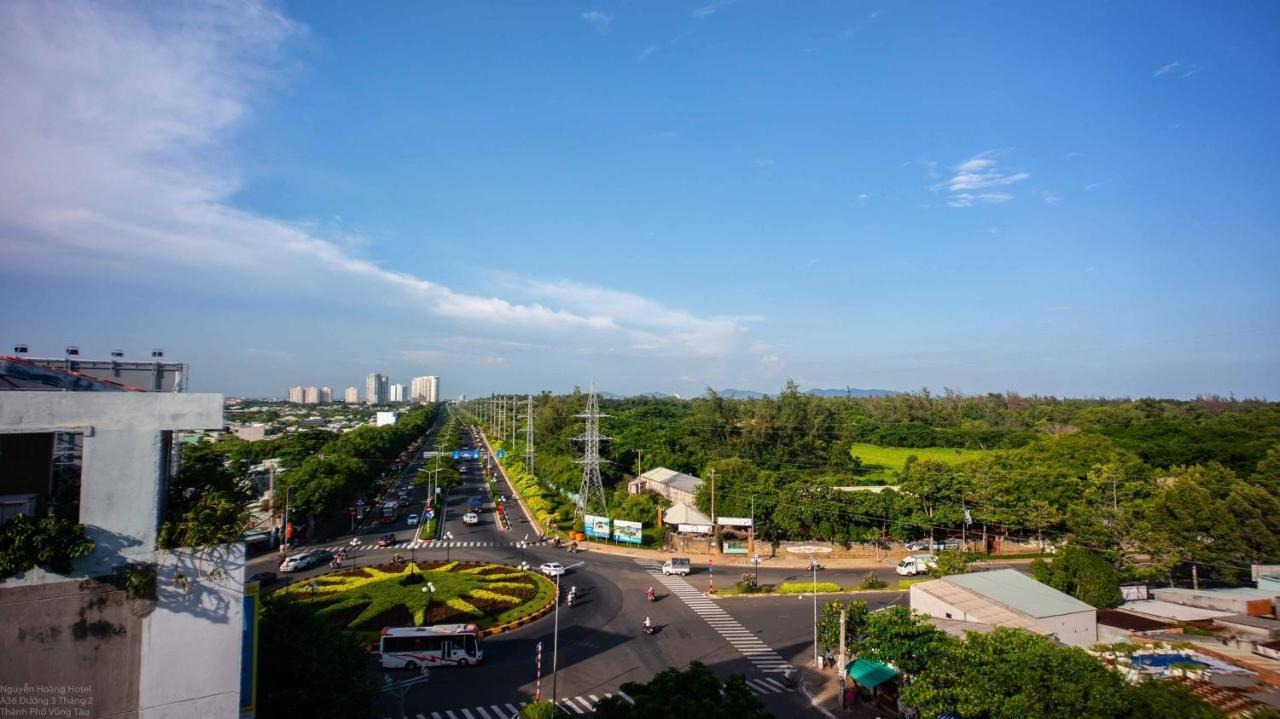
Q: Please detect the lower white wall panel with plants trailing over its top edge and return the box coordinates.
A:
[138,544,247,719]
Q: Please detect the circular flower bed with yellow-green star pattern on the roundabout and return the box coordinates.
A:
[279,562,556,631]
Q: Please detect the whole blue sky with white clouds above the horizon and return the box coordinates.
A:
[0,0,1280,398]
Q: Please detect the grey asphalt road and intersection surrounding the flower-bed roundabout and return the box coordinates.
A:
[250,414,1013,719]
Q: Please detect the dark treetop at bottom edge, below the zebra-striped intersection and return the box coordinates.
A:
[595,661,769,719]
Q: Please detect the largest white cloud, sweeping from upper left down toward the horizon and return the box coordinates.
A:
[0,1,745,356]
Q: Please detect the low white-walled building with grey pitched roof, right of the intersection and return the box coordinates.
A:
[911,569,1098,646]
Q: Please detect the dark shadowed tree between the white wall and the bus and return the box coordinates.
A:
[257,599,374,719]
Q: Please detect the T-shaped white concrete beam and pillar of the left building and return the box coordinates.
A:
[0,391,223,587]
